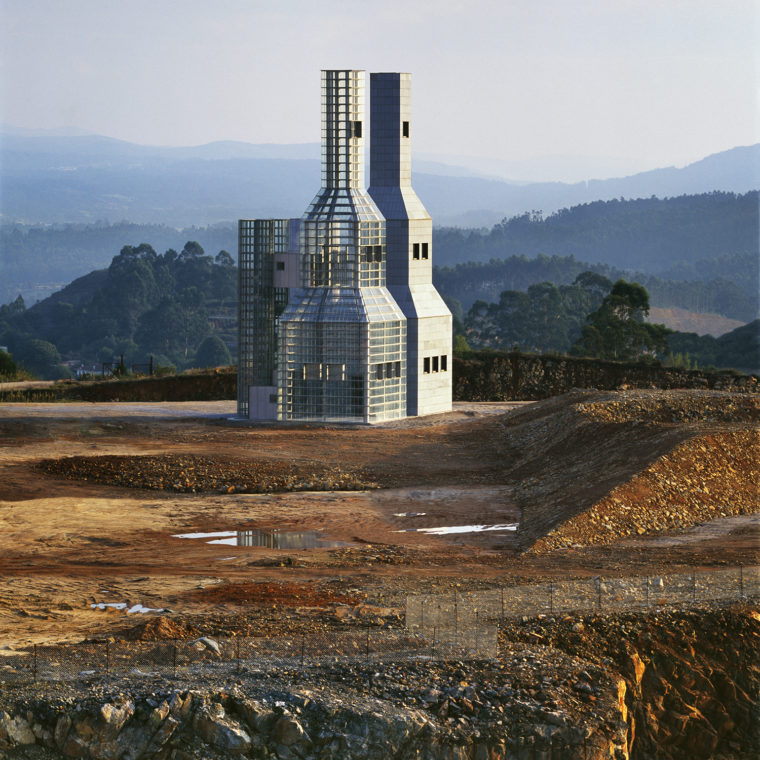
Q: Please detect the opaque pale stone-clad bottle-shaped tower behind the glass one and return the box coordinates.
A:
[369,73,452,416]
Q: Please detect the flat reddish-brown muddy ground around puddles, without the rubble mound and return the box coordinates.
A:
[0,394,760,653]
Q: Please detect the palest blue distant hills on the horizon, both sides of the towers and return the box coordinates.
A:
[0,133,760,227]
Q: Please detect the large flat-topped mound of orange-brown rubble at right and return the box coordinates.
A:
[502,390,760,552]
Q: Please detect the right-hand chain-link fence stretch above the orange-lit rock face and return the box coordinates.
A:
[406,565,760,636]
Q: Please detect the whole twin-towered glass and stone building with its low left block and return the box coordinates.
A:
[238,70,451,423]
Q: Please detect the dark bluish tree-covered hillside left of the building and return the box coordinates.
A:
[0,241,237,378]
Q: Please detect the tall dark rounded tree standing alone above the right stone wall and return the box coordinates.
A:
[572,280,670,361]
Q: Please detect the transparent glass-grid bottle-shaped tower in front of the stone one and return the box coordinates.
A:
[277,71,406,422]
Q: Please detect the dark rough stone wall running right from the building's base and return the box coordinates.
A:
[454,351,760,401]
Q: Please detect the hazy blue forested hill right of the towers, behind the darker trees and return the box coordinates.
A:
[434,191,760,270]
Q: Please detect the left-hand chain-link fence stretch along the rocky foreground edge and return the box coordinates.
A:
[0,627,496,691]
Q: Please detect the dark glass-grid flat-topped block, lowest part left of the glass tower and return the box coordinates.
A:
[238,219,290,417]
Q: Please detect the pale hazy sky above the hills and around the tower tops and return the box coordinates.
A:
[0,0,760,171]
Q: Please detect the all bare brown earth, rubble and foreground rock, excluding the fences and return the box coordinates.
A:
[0,391,760,760]
